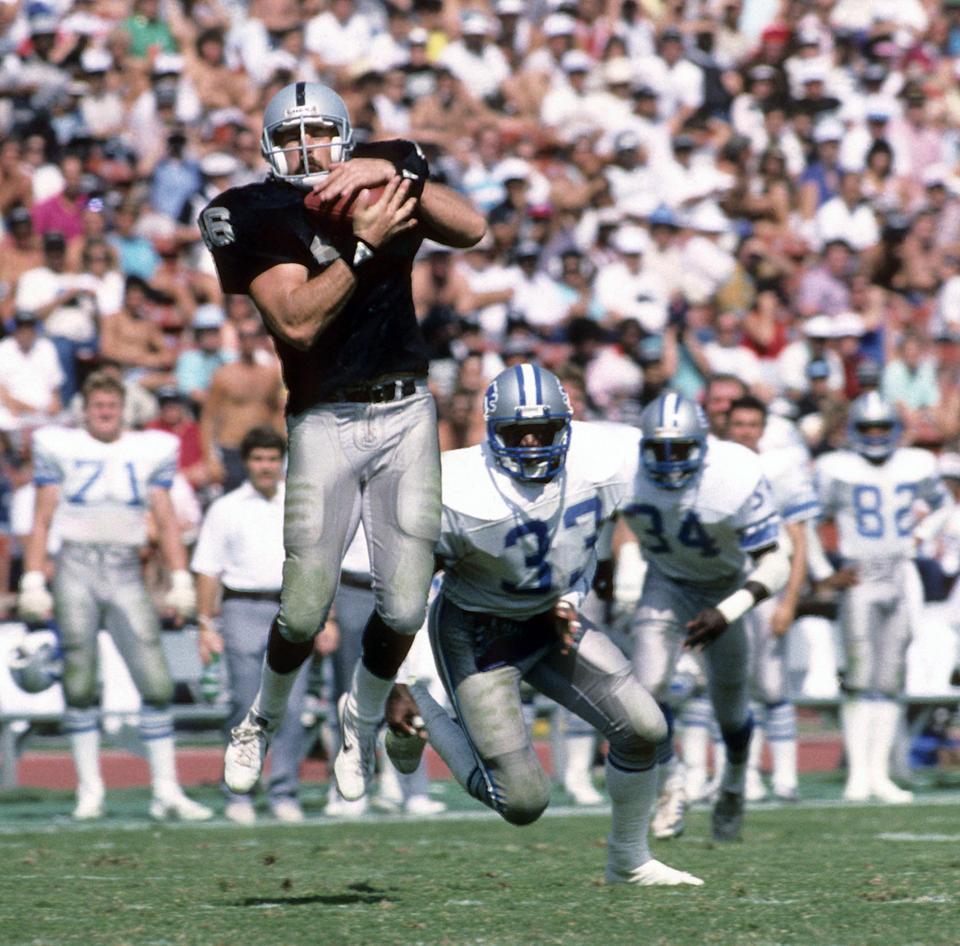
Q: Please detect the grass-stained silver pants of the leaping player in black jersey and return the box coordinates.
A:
[280,382,440,642]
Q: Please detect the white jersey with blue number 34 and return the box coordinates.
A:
[623,437,780,585]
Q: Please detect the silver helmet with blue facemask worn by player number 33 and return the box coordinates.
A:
[483,363,573,482]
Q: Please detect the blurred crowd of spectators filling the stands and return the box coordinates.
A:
[0,0,960,692]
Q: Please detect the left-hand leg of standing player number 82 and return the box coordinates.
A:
[839,582,878,801]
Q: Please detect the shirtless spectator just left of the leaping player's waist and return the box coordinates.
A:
[200,318,285,491]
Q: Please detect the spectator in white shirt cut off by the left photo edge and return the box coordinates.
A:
[0,311,63,430]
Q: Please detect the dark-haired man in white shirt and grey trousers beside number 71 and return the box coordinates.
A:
[191,427,323,825]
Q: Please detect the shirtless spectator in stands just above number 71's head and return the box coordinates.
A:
[100,276,176,390]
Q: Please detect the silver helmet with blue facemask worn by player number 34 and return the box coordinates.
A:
[640,391,707,489]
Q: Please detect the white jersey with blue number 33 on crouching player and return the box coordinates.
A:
[437,422,640,619]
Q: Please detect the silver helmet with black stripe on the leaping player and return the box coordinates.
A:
[260,82,353,190]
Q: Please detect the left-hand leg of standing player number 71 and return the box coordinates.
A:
[53,546,104,821]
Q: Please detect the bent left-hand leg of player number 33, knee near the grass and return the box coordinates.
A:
[410,593,550,825]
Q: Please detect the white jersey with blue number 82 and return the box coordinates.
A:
[815,447,949,562]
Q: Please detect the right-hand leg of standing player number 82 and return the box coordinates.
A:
[867,580,919,804]
